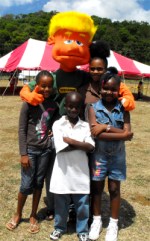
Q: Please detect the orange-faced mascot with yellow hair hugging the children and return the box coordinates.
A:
[20,11,135,115]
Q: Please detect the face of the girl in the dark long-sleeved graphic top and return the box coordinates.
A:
[38,75,53,99]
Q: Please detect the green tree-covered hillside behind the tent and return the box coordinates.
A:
[0,11,150,64]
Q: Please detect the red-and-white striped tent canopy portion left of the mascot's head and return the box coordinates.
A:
[0,38,59,72]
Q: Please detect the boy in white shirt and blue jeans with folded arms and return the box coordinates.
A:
[50,92,94,241]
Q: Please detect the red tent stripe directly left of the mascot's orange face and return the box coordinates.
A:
[40,43,60,71]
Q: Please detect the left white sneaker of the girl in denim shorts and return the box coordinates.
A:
[89,221,102,240]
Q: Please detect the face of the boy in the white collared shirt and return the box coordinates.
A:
[65,96,82,119]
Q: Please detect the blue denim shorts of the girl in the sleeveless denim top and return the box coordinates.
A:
[90,141,126,181]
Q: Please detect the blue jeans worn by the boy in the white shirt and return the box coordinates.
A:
[54,194,89,234]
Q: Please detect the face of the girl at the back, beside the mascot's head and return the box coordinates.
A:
[89,58,106,81]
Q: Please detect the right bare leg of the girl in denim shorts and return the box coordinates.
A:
[108,179,120,219]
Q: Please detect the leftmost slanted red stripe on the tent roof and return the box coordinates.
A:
[5,41,28,72]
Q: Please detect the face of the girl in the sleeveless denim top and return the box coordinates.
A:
[101,78,119,102]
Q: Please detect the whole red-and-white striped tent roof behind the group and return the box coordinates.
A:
[0,38,150,77]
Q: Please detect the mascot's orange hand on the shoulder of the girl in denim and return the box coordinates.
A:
[119,82,135,111]
